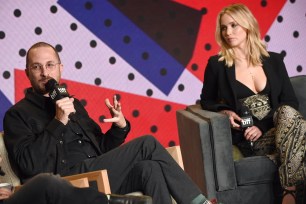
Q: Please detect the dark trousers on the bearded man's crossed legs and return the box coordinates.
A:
[71,136,202,204]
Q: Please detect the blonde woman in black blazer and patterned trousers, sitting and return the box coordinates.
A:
[201,4,306,203]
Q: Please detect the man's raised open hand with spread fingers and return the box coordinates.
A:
[104,95,126,128]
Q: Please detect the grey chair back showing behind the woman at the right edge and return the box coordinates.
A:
[290,75,306,118]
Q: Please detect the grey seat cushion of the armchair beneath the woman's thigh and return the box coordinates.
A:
[234,156,277,186]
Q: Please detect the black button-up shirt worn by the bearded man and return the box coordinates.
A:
[3,88,130,182]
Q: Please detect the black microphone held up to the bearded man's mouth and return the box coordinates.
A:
[45,78,76,121]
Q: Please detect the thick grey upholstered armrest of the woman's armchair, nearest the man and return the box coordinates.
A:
[177,105,237,197]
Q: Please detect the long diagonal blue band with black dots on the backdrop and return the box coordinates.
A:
[58,0,184,95]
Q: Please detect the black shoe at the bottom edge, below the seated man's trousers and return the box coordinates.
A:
[108,194,152,204]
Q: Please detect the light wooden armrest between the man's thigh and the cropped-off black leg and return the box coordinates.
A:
[62,170,111,194]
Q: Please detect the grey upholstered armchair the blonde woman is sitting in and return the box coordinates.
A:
[176,76,306,204]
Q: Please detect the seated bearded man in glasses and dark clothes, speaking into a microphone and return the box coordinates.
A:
[4,42,213,204]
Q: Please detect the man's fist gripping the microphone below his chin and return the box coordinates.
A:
[55,97,75,125]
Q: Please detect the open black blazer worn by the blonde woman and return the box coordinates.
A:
[201,52,298,132]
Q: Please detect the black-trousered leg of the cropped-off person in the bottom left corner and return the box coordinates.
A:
[0,174,108,204]
